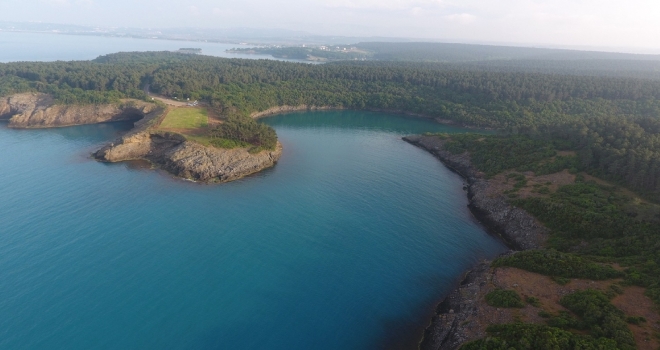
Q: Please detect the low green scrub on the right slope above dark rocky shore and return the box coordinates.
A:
[430,130,660,349]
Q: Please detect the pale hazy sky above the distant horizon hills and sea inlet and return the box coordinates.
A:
[0,0,660,50]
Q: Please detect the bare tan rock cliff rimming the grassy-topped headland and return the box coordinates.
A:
[94,130,282,182]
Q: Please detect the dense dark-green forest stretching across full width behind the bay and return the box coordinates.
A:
[0,52,660,200]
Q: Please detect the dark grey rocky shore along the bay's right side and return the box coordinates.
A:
[403,135,549,350]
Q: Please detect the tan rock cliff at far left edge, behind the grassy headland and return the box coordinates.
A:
[0,93,158,128]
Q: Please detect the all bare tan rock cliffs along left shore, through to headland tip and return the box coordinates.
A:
[0,93,282,182]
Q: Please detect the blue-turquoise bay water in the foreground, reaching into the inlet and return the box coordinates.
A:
[0,111,504,350]
